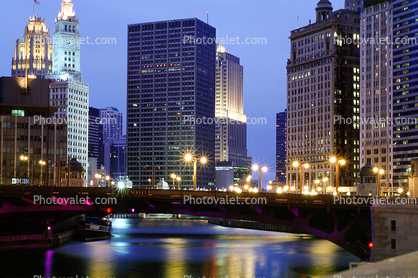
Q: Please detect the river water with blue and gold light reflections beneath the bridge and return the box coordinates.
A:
[0,219,358,278]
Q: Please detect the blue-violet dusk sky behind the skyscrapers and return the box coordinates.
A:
[0,0,344,182]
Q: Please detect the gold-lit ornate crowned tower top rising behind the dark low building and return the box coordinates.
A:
[12,16,52,78]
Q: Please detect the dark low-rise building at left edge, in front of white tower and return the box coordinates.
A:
[0,77,67,186]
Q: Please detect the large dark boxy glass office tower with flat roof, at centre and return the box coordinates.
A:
[126,19,216,187]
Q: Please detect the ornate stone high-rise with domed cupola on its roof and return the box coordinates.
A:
[287,0,360,191]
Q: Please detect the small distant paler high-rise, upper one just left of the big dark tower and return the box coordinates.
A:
[100,107,123,141]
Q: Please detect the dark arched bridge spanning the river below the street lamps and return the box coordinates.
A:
[0,186,372,260]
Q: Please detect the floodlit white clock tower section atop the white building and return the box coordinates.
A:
[53,0,80,76]
